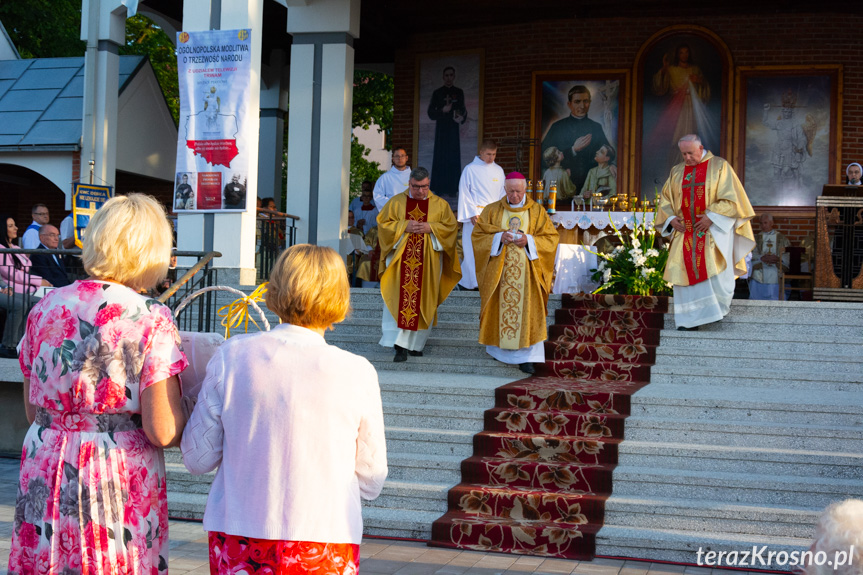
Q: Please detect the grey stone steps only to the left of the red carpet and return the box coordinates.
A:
[166,288,560,539]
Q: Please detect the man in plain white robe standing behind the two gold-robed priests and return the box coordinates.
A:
[458,140,506,289]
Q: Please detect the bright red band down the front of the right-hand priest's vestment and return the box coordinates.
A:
[681,161,709,285]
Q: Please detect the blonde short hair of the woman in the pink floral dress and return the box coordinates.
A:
[81,194,173,291]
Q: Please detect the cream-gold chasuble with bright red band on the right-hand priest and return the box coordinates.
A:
[654,152,755,286]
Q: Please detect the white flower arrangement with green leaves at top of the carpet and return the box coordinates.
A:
[588,213,671,295]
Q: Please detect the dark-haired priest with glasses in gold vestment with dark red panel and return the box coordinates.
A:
[378,168,461,361]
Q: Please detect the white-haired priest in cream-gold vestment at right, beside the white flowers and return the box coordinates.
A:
[654,134,755,331]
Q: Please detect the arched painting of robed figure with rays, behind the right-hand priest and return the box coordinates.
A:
[633,26,733,200]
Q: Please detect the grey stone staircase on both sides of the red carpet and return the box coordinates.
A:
[167,289,863,568]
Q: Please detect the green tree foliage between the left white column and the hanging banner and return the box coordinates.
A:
[120,14,180,124]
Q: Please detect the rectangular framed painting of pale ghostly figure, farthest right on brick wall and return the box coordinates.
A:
[735,65,842,207]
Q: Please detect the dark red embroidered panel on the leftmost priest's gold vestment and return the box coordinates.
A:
[396,197,429,331]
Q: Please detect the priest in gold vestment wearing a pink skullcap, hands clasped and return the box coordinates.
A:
[471,172,559,374]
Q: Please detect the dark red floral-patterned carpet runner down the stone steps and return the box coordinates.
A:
[429,294,668,560]
